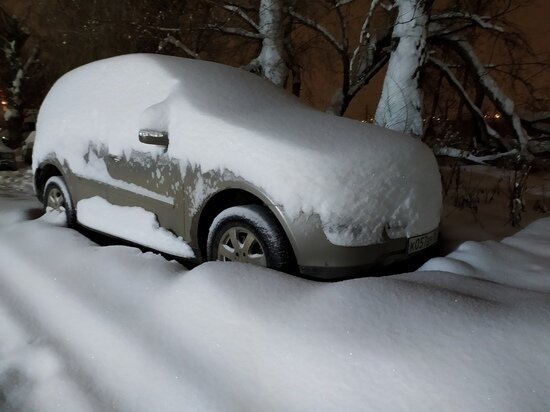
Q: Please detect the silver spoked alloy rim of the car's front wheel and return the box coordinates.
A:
[218,226,267,267]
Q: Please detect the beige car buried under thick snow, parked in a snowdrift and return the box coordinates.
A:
[33,54,441,279]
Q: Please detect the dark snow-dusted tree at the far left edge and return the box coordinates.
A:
[0,7,38,147]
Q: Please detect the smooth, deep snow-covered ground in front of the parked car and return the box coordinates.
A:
[0,167,550,412]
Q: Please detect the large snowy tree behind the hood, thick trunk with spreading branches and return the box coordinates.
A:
[289,0,540,160]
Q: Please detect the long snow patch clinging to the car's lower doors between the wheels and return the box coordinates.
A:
[77,196,195,258]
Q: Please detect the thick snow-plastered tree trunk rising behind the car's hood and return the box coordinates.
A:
[375,0,431,137]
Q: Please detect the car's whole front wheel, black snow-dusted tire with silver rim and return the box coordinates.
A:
[207,205,292,271]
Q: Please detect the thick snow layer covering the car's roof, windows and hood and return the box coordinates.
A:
[33,55,441,245]
